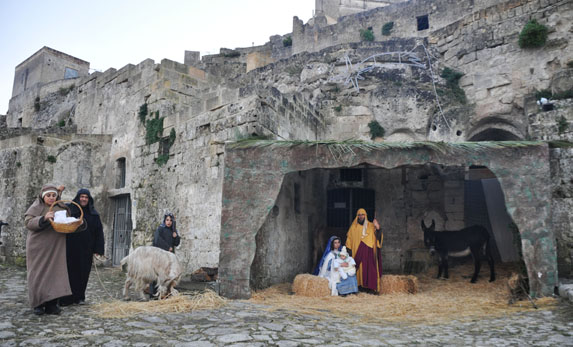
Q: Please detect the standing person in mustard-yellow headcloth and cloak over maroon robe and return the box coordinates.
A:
[346,208,383,293]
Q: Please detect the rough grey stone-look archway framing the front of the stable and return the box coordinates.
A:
[219,141,557,298]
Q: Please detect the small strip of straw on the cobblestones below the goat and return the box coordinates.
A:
[92,290,227,318]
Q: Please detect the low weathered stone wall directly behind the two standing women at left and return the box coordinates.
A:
[0,135,110,264]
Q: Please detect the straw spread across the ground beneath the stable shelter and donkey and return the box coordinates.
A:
[249,264,557,324]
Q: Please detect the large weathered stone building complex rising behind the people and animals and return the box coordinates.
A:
[0,0,573,297]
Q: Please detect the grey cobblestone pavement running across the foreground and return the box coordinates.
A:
[0,265,573,346]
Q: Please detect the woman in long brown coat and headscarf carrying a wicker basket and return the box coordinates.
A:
[25,185,72,315]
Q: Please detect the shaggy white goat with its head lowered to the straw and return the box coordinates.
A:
[121,246,182,300]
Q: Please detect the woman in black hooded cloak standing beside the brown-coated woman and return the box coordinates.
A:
[60,189,104,306]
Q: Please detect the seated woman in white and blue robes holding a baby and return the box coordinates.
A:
[315,236,358,296]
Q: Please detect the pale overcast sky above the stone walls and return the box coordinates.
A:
[0,0,315,114]
